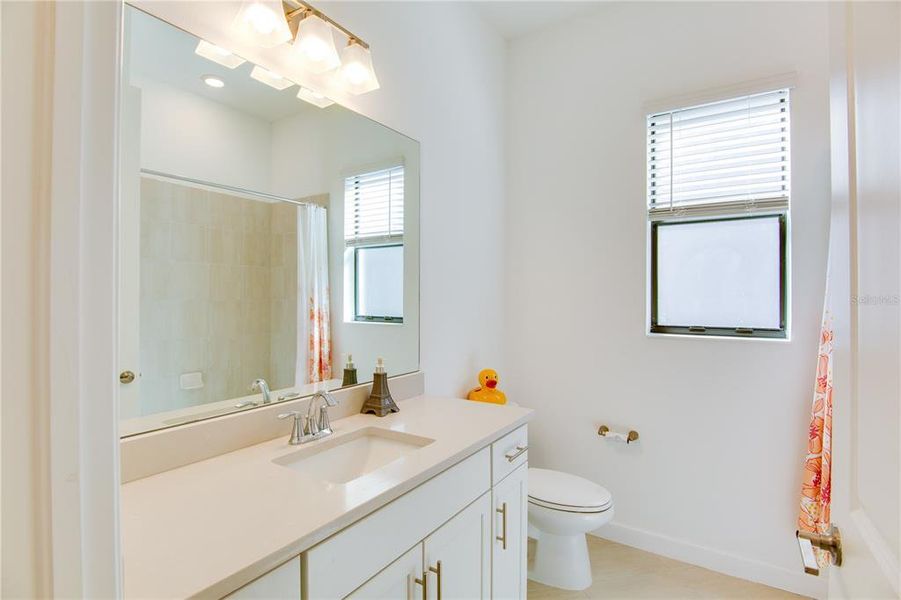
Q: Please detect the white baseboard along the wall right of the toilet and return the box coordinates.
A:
[591,521,827,598]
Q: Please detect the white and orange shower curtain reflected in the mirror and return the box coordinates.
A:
[295,204,332,385]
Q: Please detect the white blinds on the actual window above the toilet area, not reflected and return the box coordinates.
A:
[647,90,790,219]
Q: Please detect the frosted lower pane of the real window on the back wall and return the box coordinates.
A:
[657,217,781,329]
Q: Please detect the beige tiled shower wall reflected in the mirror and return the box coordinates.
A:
[140,177,297,414]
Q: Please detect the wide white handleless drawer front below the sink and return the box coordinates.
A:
[302,448,491,600]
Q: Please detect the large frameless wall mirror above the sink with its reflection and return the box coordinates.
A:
[119,7,419,435]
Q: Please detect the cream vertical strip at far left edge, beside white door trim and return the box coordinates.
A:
[0,2,53,598]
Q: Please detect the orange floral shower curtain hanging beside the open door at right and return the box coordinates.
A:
[798,273,833,566]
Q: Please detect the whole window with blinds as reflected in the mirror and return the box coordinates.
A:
[344,166,404,323]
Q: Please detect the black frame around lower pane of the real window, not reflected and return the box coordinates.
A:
[649,212,788,340]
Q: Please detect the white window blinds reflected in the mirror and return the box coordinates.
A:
[344,166,404,246]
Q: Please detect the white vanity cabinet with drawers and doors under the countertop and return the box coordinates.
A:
[282,426,528,600]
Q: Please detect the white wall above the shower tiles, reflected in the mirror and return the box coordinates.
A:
[131,79,272,191]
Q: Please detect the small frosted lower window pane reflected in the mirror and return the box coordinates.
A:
[357,246,404,317]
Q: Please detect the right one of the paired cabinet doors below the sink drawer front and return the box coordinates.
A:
[424,492,491,600]
